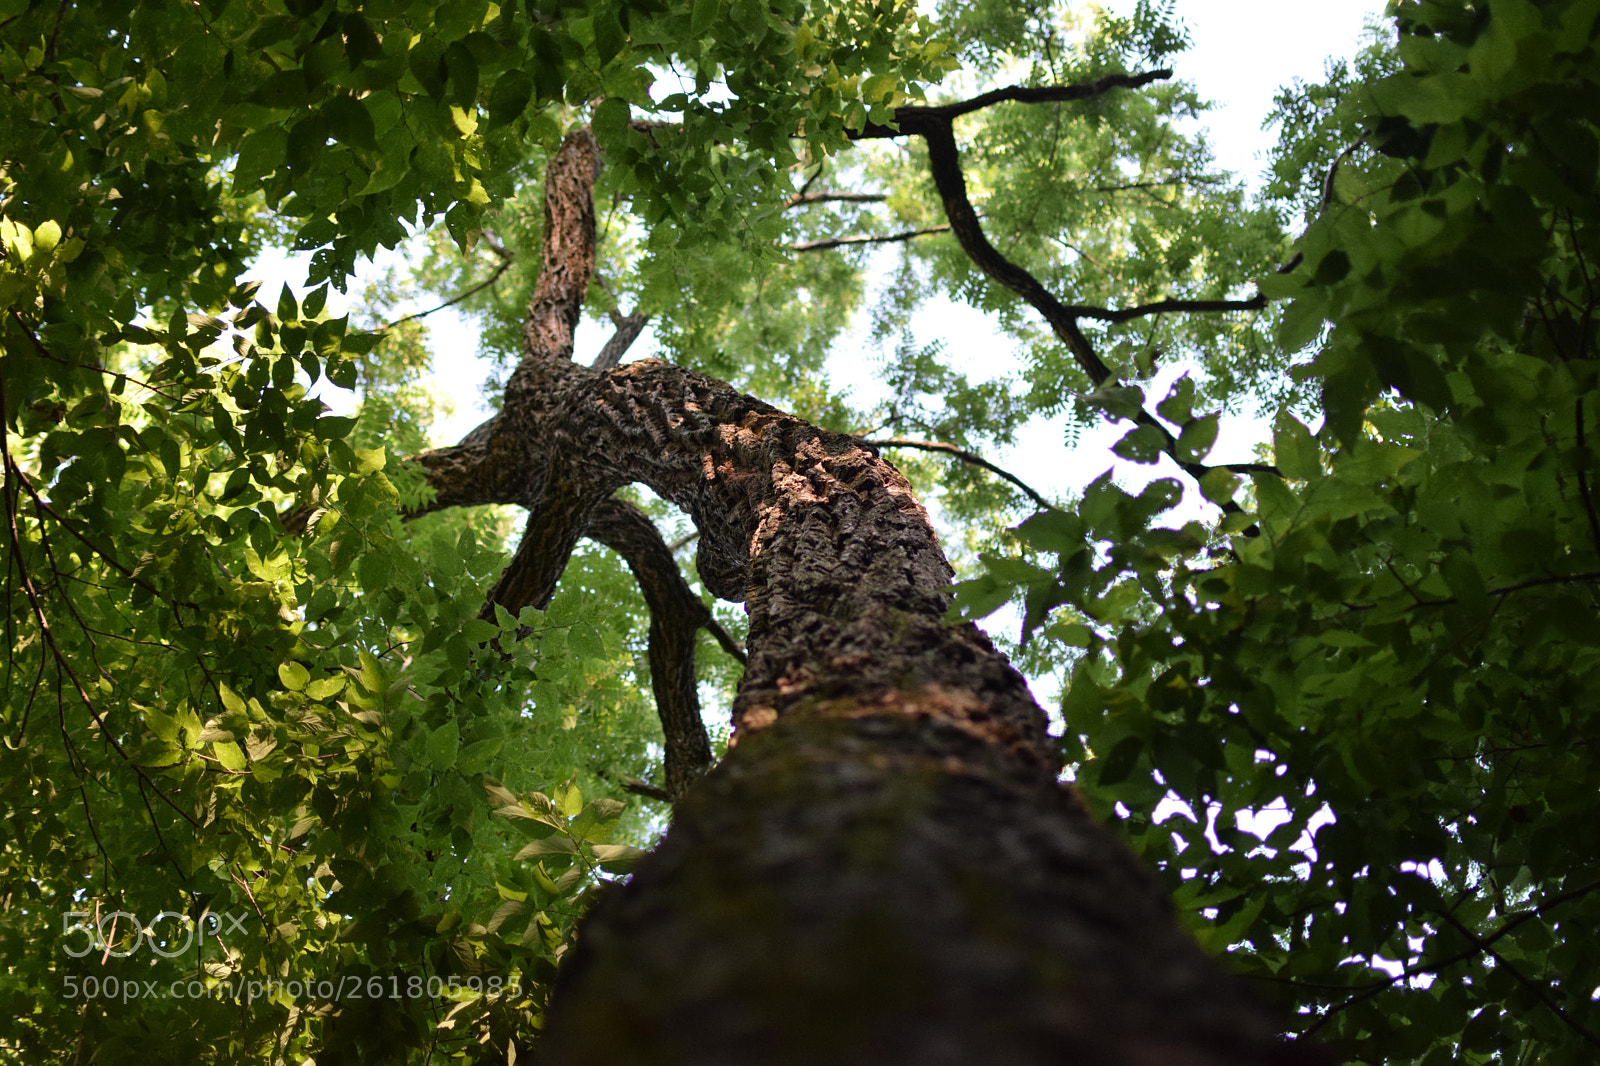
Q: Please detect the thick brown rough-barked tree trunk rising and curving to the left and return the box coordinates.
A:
[421,126,1312,1066]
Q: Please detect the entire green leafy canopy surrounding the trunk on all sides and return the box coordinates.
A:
[0,0,1600,1066]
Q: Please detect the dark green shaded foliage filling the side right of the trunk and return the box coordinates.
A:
[972,2,1600,1064]
